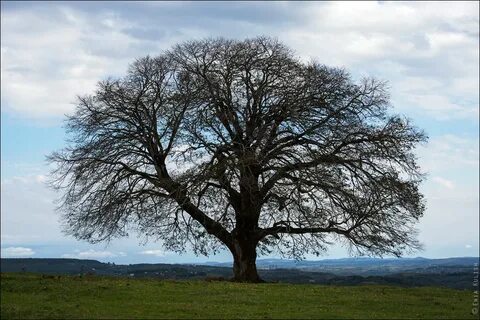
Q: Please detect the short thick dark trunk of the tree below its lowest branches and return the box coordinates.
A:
[232,236,263,282]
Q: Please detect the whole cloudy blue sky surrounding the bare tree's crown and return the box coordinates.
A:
[1,1,479,263]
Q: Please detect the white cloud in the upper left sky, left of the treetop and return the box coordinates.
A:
[1,7,165,118]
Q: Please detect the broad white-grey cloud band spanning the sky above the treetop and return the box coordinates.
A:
[2,1,479,119]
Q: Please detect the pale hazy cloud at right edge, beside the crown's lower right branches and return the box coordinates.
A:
[418,134,479,256]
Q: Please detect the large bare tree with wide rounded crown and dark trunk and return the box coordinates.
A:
[49,38,426,282]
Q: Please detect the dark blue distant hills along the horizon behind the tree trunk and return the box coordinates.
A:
[0,257,479,290]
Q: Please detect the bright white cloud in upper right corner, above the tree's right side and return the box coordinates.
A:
[280,1,479,121]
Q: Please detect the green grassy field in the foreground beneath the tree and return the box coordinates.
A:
[1,273,476,319]
